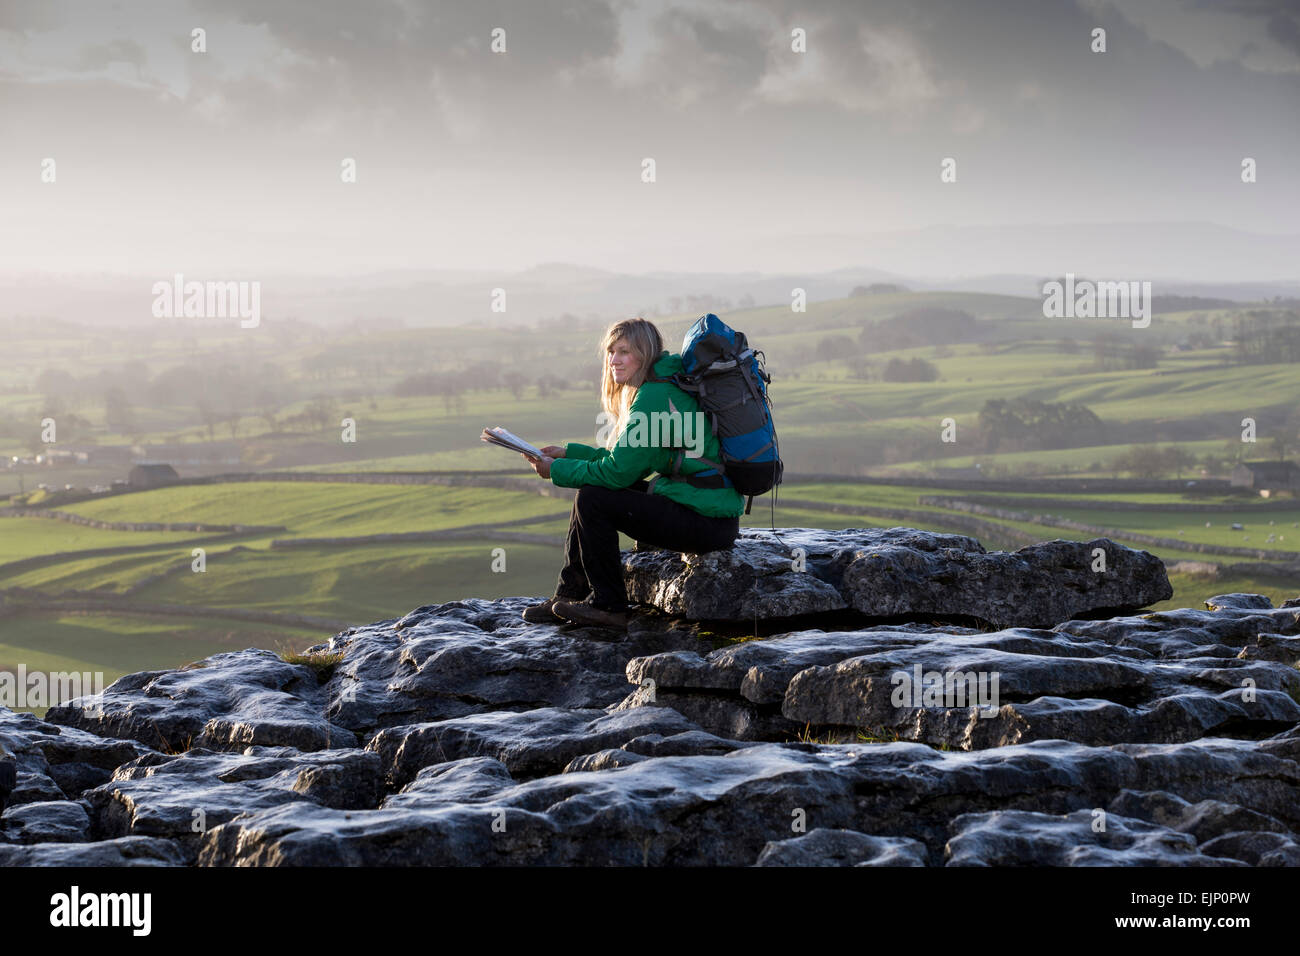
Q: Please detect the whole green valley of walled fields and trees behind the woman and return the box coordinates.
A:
[0,293,1300,712]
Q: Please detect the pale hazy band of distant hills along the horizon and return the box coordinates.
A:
[0,222,1300,328]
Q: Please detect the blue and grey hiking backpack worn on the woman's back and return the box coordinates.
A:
[649,312,784,515]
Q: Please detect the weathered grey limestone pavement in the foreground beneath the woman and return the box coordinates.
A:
[0,528,1300,866]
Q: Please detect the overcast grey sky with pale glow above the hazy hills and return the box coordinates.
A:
[0,0,1300,278]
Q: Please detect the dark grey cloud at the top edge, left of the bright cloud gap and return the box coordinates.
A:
[179,0,618,135]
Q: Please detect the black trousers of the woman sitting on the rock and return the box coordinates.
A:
[555,481,740,611]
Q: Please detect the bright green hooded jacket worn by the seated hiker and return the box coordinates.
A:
[551,350,745,518]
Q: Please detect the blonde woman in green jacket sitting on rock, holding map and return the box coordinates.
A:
[524,319,745,628]
